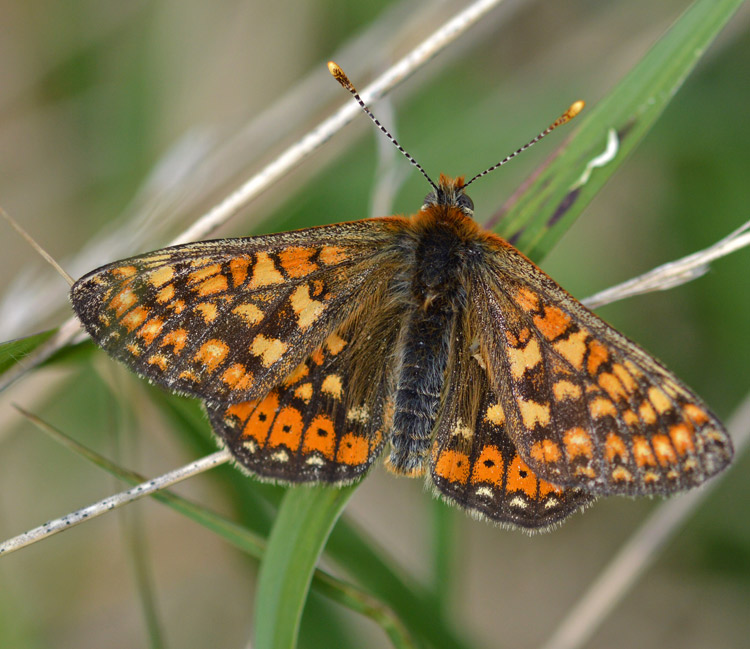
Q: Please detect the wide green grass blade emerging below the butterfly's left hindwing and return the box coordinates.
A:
[254,485,356,649]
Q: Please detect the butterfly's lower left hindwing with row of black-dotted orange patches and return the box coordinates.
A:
[206,282,400,484]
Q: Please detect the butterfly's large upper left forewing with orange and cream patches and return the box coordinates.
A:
[71,219,406,403]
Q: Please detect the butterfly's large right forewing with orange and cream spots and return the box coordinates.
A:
[472,238,732,495]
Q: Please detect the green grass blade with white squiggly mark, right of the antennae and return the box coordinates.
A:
[488,0,743,260]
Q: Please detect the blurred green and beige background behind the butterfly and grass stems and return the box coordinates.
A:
[0,0,750,648]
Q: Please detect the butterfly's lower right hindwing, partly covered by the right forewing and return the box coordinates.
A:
[431,318,592,530]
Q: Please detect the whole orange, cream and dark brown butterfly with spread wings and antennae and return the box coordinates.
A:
[71,64,732,530]
